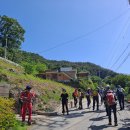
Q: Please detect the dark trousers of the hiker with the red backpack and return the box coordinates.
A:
[108,104,117,124]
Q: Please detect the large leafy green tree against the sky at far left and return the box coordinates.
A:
[0,15,25,58]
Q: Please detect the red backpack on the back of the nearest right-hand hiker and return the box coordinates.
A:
[106,93,116,106]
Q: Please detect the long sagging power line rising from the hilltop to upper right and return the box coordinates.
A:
[37,9,129,53]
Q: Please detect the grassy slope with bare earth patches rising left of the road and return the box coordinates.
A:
[0,59,73,110]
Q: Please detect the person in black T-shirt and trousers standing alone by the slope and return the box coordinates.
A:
[60,88,69,115]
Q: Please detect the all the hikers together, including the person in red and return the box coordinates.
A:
[20,85,124,126]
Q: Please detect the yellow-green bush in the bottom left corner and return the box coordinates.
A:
[0,97,17,130]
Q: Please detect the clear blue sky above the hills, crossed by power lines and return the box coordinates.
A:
[0,0,130,74]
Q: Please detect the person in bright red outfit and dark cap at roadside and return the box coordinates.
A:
[20,86,35,125]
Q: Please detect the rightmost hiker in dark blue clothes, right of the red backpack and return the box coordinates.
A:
[116,85,125,110]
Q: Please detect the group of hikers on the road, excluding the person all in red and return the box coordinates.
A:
[61,85,124,126]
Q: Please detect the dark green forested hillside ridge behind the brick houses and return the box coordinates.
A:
[9,51,117,79]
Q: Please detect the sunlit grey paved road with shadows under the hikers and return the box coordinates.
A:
[31,101,130,130]
